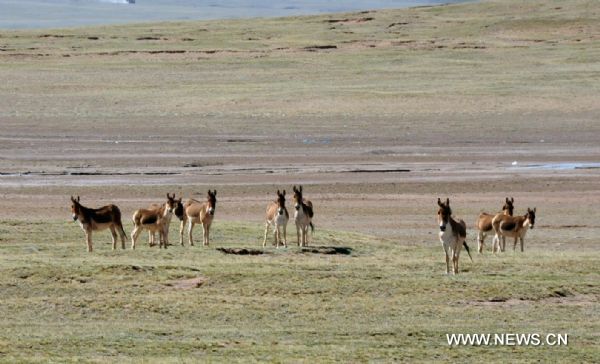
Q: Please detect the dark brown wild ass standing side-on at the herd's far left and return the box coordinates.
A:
[71,196,127,252]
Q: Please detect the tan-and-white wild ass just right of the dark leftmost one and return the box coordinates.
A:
[131,193,177,249]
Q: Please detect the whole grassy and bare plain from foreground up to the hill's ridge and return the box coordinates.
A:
[0,0,600,363]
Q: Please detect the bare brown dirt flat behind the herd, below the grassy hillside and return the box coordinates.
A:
[0,128,600,251]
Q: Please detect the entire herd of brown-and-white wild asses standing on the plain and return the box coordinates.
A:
[71,186,536,274]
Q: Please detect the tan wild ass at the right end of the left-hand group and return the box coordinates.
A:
[179,190,217,246]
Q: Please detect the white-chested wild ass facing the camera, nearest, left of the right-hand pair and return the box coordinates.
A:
[438,198,473,274]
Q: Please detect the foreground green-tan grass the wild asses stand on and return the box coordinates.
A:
[0,220,600,362]
